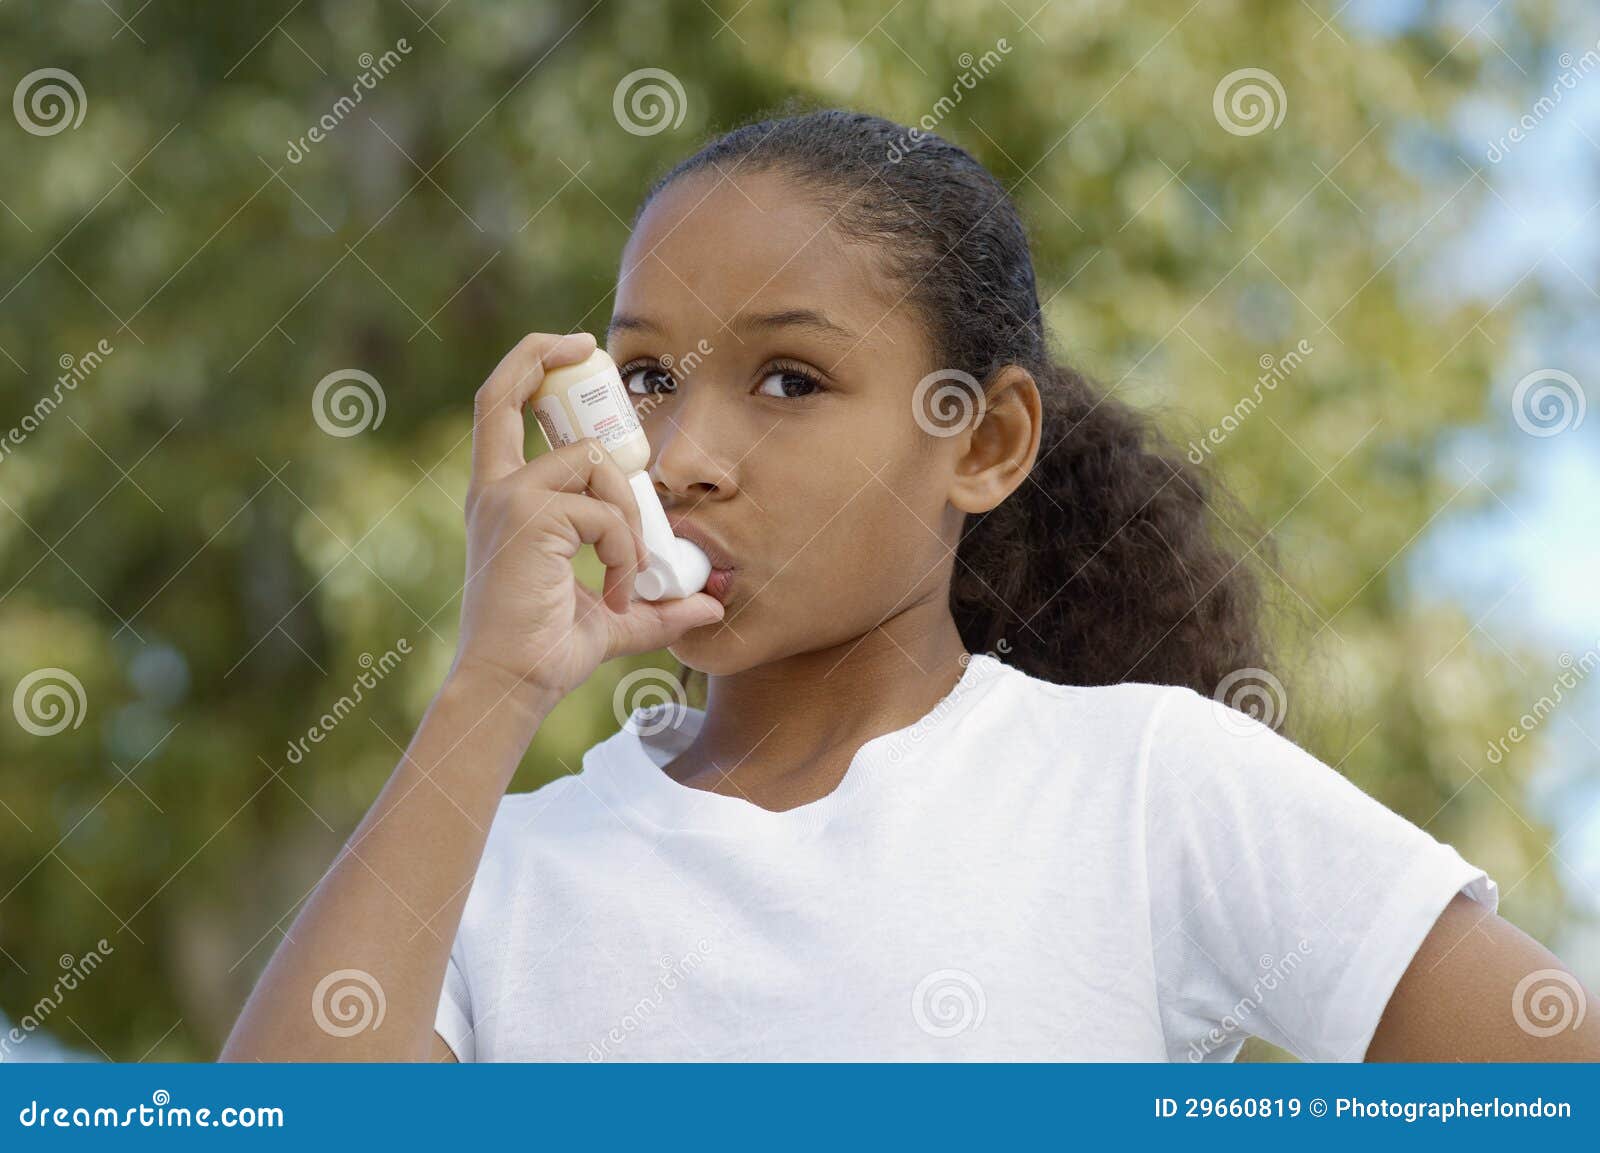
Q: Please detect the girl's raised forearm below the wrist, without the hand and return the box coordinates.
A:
[222,672,555,1060]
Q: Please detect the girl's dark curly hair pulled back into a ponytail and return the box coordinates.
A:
[635,109,1266,696]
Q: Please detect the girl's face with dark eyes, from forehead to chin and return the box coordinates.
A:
[608,171,965,675]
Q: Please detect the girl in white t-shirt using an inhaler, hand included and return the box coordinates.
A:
[224,112,1600,1060]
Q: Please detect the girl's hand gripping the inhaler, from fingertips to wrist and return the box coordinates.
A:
[451,333,723,708]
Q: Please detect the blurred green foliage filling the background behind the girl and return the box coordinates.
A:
[0,0,1570,1059]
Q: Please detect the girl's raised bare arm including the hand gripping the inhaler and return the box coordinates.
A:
[222,327,722,1060]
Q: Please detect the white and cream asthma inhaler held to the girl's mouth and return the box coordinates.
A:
[528,349,710,601]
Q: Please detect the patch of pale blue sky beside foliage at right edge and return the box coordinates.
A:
[1376,0,1600,933]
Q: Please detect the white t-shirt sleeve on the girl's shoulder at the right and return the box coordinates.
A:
[1142,688,1499,1060]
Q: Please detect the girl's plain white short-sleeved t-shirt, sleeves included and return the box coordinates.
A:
[435,654,1499,1060]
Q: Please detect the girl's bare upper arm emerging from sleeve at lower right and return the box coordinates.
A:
[1366,896,1600,1060]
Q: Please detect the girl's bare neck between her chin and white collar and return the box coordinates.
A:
[667,601,966,809]
